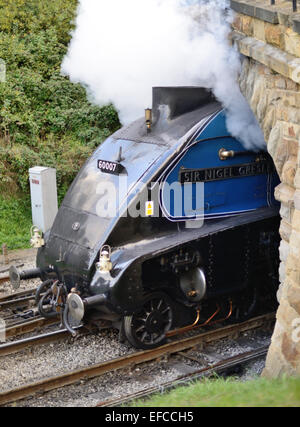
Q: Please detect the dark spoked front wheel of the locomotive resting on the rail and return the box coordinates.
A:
[123,293,173,350]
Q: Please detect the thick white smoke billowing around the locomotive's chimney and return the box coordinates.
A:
[62,0,265,149]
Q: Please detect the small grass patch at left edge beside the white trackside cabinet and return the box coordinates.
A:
[0,194,32,250]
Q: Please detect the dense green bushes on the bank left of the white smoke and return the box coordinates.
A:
[0,0,120,198]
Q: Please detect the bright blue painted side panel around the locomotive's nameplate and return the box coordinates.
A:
[161,111,279,221]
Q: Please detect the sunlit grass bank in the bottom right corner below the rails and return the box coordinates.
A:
[131,378,300,408]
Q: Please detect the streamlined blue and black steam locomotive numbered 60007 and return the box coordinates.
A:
[10,87,279,349]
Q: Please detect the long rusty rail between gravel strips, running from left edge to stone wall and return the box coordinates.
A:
[0,313,275,405]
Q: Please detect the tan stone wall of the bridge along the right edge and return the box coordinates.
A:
[232,0,300,377]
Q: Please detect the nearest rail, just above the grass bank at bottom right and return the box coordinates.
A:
[96,346,269,408]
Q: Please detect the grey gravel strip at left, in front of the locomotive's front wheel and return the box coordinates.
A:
[0,330,133,391]
